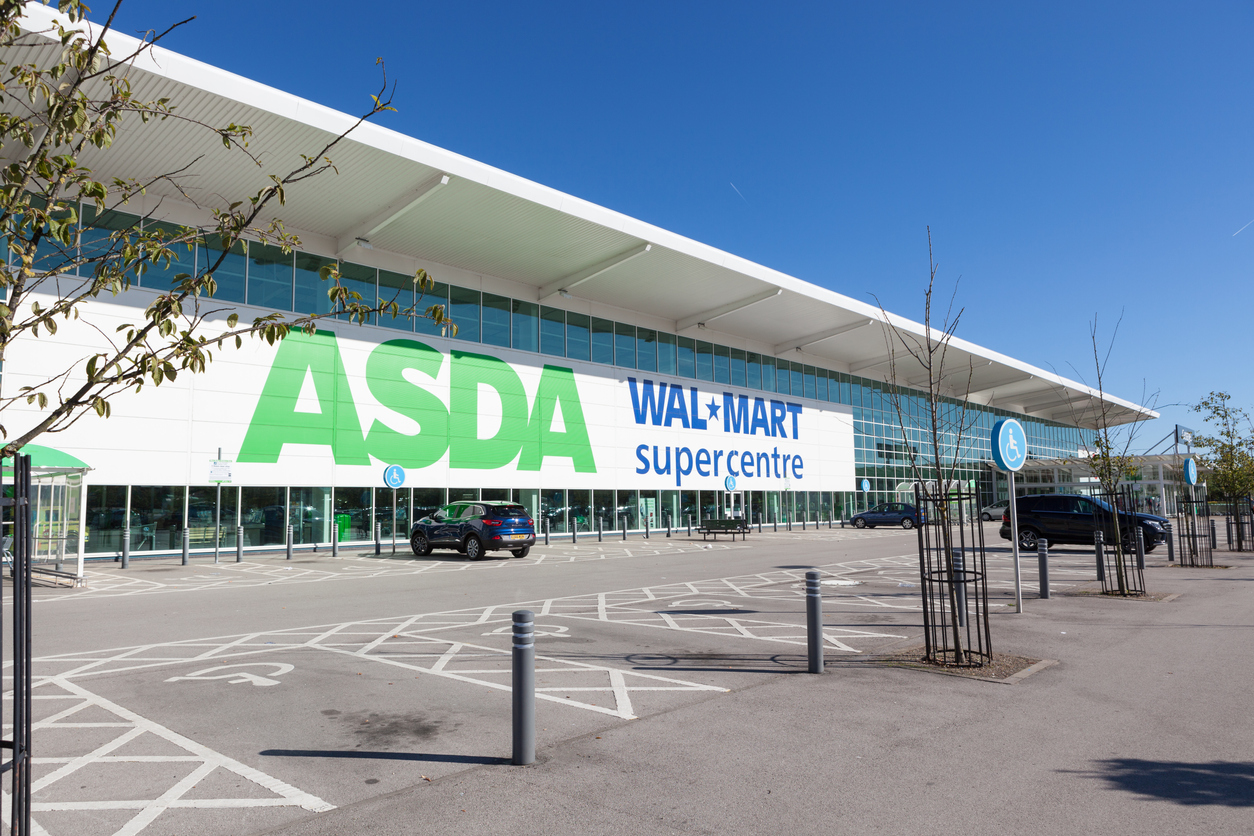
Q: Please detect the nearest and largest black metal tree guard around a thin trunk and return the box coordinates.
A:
[914,485,993,668]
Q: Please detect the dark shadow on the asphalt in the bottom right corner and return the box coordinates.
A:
[1085,757,1254,807]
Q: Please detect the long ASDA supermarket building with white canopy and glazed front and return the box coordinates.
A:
[4,8,1154,558]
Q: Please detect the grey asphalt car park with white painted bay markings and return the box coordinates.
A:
[9,524,1254,836]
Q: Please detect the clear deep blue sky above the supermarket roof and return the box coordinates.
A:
[110,0,1254,447]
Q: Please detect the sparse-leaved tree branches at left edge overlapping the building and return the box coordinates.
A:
[0,0,455,456]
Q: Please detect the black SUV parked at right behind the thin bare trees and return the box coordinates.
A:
[998,494,1167,551]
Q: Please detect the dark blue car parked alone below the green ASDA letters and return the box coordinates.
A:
[409,503,535,560]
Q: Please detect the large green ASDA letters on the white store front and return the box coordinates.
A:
[240,331,597,473]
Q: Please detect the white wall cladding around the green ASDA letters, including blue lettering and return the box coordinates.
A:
[4,291,855,490]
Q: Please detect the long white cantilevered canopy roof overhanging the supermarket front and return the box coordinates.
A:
[23,5,1156,427]
